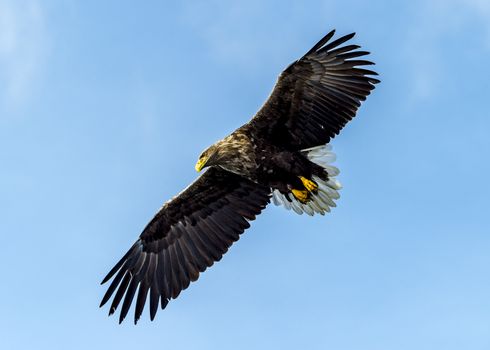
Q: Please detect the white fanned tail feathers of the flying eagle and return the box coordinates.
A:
[272,144,342,215]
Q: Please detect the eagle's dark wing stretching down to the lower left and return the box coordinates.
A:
[101,168,270,323]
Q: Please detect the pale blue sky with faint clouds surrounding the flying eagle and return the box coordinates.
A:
[0,0,490,350]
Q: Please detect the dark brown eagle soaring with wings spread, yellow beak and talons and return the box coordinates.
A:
[100,30,379,324]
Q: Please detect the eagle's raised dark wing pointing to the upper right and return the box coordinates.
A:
[249,31,379,150]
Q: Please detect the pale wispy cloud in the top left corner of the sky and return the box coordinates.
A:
[0,0,48,107]
